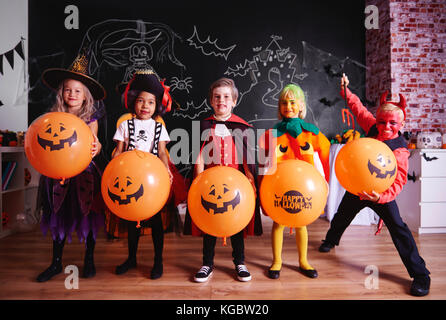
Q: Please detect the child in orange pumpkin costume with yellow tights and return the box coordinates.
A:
[259,84,330,279]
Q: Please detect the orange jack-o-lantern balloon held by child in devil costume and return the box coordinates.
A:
[335,138,398,195]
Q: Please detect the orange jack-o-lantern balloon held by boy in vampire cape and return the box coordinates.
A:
[187,166,255,237]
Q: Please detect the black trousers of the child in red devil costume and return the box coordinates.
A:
[325,191,430,278]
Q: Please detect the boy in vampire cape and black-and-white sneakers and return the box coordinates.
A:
[184,78,262,282]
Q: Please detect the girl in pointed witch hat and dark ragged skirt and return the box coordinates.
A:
[37,53,106,282]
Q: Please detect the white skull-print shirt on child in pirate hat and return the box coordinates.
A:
[113,118,170,152]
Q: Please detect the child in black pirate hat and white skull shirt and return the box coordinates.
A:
[113,70,172,279]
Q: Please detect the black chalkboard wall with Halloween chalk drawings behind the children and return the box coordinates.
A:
[29,0,365,174]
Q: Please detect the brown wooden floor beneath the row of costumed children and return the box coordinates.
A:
[0,217,446,300]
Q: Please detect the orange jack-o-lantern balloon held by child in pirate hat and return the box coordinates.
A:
[101,150,170,222]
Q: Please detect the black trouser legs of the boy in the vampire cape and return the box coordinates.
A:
[203,230,245,267]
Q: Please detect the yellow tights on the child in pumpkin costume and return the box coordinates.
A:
[270,222,314,271]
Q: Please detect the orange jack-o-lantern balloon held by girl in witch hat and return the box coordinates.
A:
[25,112,94,179]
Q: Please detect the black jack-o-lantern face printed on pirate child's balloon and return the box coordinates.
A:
[108,176,144,205]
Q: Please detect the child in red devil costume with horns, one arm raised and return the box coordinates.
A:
[319,75,430,296]
